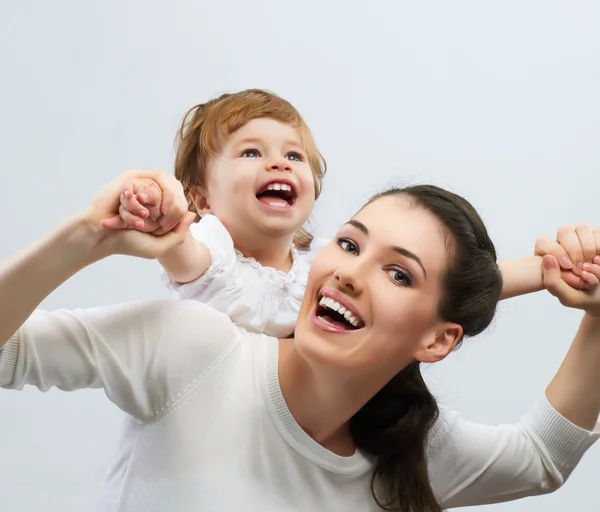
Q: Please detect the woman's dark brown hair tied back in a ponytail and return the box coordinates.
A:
[350,185,502,512]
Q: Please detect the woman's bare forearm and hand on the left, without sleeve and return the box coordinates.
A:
[0,172,193,348]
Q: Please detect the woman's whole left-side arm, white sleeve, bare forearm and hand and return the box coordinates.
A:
[0,173,230,420]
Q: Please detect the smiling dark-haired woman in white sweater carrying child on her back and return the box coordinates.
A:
[0,172,600,512]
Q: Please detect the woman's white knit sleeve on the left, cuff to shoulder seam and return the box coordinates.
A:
[0,301,237,421]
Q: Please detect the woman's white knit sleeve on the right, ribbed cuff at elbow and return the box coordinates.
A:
[428,396,600,508]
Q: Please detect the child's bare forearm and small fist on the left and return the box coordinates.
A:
[109,179,211,284]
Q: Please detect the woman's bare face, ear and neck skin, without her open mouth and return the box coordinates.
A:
[279,197,462,454]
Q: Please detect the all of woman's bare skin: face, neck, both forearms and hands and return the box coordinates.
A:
[0,171,600,455]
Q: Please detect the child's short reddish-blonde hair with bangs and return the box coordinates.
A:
[175,89,327,249]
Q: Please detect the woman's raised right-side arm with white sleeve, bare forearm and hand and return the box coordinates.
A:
[430,240,600,507]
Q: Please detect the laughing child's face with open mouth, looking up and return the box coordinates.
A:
[195,119,315,245]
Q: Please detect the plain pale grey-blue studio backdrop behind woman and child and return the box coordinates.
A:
[0,0,600,512]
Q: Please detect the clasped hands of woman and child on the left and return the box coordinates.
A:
[84,171,195,258]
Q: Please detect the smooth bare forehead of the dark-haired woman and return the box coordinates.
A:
[354,196,449,274]
